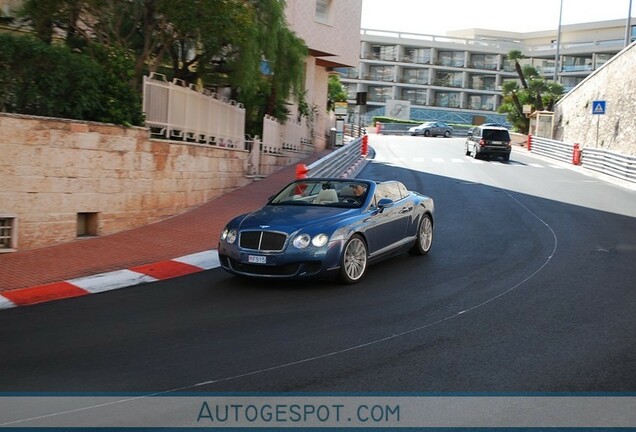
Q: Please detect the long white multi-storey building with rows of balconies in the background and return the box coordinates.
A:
[339,20,636,124]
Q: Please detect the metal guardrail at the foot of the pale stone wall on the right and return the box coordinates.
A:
[530,136,636,183]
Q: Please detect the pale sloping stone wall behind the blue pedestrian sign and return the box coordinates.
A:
[555,43,636,155]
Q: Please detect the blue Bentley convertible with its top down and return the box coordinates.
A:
[218,178,434,283]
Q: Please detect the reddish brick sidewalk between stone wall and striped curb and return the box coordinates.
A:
[0,150,329,309]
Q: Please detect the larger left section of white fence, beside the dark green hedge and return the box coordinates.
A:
[143,73,245,149]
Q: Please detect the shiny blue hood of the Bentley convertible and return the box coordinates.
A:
[238,205,360,234]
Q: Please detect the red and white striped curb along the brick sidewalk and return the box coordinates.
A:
[0,250,220,309]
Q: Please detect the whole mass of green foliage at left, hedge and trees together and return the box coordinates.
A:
[6,0,310,133]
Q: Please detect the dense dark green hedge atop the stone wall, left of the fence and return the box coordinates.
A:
[0,34,143,125]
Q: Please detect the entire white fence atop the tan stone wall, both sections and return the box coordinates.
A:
[143,73,315,178]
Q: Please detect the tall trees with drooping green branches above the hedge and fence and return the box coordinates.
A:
[13,0,307,131]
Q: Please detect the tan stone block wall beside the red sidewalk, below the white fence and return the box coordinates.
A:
[0,113,253,250]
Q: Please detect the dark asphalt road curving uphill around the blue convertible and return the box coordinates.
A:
[0,136,636,393]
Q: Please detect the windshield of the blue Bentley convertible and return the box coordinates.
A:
[269,179,369,208]
